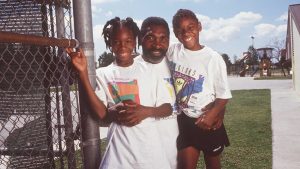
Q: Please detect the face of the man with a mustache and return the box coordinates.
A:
[142,25,169,64]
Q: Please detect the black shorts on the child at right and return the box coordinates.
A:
[177,113,229,155]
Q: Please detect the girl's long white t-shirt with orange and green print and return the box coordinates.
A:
[96,57,172,169]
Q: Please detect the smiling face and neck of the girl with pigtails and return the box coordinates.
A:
[111,26,136,67]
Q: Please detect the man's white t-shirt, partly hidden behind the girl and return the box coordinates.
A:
[135,56,179,169]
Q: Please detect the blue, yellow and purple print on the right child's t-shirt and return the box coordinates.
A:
[173,71,204,109]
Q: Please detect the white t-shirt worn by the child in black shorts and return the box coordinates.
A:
[167,43,232,118]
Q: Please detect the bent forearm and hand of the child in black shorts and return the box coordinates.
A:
[195,98,228,130]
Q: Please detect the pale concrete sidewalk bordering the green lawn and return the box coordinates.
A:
[229,77,300,169]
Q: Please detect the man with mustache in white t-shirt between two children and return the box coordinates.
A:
[135,17,178,169]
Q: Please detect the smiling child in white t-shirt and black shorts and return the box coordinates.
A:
[167,9,232,169]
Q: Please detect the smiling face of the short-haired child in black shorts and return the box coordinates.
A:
[174,17,201,50]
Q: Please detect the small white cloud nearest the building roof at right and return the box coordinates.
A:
[254,23,287,38]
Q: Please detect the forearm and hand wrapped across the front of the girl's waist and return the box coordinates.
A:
[117,101,172,126]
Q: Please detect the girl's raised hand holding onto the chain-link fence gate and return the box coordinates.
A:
[66,48,87,73]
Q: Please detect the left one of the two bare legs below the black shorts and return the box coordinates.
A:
[177,146,200,169]
